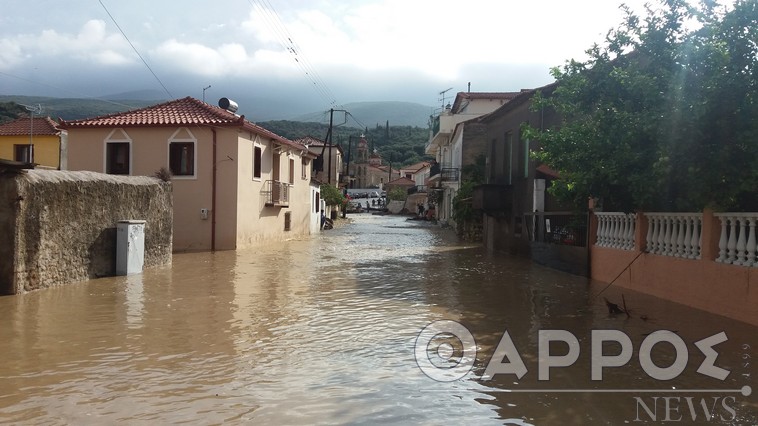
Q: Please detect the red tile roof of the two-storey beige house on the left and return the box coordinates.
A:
[60,96,305,150]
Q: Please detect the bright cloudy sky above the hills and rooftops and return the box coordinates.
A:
[0,0,660,119]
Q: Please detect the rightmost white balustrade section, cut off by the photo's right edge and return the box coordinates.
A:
[714,213,758,266]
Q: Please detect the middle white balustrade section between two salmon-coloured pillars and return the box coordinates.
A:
[645,213,703,259]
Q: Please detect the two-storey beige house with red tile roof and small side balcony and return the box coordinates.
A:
[61,97,321,251]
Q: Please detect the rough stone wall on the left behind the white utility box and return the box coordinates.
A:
[0,170,173,294]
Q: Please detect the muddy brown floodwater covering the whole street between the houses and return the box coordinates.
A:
[0,214,758,425]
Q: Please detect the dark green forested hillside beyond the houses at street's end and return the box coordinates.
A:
[258,120,432,167]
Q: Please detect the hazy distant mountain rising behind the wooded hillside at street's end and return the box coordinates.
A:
[288,101,433,128]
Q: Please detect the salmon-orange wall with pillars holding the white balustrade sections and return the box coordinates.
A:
[590,210,758,325]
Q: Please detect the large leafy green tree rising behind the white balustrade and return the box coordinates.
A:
[527,0,758,211]
